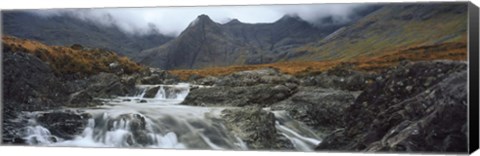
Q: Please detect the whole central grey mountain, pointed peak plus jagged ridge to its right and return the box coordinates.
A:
[136,15,342,69]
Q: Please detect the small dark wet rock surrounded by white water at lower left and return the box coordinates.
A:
[37,111,89,139]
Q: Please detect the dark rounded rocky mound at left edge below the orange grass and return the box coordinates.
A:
[2,51,68,118]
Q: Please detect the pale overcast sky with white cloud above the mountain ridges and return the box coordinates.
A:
[35,3,372,36]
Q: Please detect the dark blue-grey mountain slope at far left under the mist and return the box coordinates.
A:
[2,11,172,56]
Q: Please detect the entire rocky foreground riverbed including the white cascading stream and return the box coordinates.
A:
[2,49,468,152]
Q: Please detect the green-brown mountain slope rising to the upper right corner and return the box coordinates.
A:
[295,3,467,60]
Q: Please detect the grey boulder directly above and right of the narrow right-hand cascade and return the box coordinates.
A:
[272,87,355,131]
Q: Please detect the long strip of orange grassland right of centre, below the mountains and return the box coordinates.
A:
[169,42,467,80]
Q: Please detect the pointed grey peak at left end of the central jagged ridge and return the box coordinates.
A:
[138,15,246,69]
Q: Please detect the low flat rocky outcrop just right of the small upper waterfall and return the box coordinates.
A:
[182,69,297,107]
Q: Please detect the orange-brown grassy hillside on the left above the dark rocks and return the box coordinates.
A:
[2,36,144,76]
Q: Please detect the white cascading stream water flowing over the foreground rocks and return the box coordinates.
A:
[20,84,320,151]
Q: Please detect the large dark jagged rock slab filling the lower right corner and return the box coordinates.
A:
[361,72,468,152]
